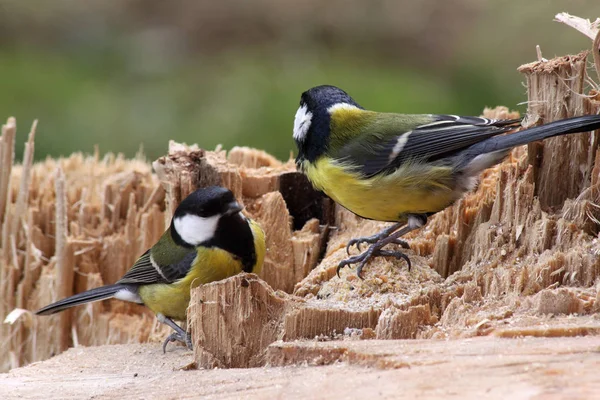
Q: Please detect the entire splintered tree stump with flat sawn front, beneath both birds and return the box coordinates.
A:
[0,47,600,399]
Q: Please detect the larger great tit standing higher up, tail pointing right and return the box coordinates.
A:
[294,85,600,277]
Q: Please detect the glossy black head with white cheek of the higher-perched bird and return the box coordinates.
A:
[294,85,362,167]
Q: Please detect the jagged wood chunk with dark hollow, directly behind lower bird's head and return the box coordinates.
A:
[153,142,333,292]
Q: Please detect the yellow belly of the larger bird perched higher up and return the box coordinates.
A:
[303,157,456,222]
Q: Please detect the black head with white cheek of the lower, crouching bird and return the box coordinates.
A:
[171,186,242,246]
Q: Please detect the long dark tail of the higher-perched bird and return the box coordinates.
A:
[464,115,600,158]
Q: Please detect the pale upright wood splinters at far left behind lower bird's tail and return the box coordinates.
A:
[0,122,164,370]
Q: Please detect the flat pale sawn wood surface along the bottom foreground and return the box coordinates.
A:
[0,336,600,400]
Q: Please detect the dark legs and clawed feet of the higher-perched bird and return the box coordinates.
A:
[337,214,427,279]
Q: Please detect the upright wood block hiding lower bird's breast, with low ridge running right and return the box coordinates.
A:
[188,273,436,368]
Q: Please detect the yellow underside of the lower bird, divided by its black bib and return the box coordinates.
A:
[139,220,266,321]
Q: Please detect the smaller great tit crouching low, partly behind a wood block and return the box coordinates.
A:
[36,186,266,352]
